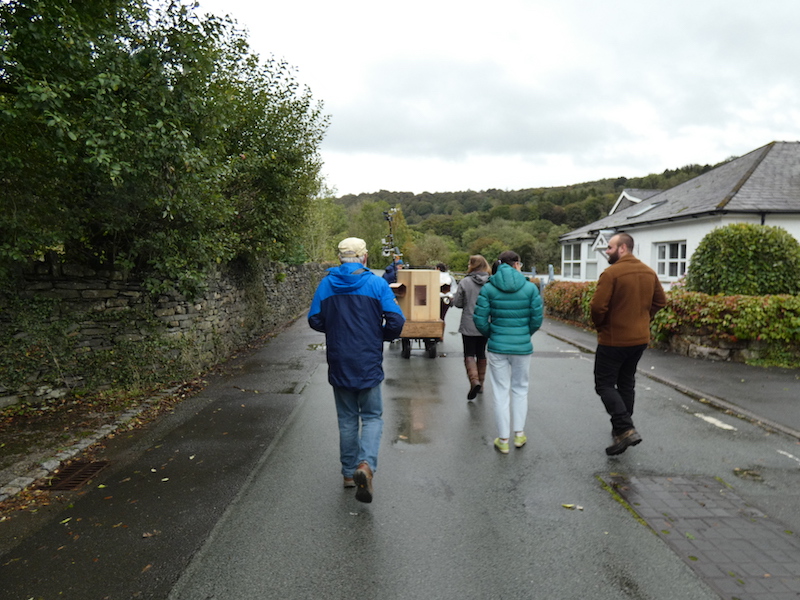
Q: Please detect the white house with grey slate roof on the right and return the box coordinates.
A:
[559,142,800,287]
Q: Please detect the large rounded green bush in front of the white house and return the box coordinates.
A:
[686,223,800,295]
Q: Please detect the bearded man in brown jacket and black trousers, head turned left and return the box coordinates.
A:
[591,233,667,456]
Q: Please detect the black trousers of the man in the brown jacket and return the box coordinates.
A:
[594,344,647,435]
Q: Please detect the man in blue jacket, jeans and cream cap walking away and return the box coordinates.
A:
[308,238,405,502]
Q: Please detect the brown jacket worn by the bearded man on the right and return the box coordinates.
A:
[591,254,667,346]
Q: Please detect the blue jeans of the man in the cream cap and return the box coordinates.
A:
[333,385,383,478]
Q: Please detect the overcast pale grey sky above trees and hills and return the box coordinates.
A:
[195,0,800,195]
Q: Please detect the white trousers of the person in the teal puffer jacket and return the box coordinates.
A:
[486,352,531,438]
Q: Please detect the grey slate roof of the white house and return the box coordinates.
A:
[559,142,800,241]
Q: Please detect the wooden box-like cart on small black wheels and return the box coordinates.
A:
[391,269,444,358]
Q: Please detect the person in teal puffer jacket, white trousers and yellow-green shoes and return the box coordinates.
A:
[473,250,544,454]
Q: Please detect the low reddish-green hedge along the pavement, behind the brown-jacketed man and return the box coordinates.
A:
[544,281,800,368]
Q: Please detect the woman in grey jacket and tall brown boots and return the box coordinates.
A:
[453,254,489,400]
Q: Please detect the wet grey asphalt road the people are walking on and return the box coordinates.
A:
[0,309,800,600]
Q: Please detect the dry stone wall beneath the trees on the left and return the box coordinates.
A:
[0,263,329,407]
